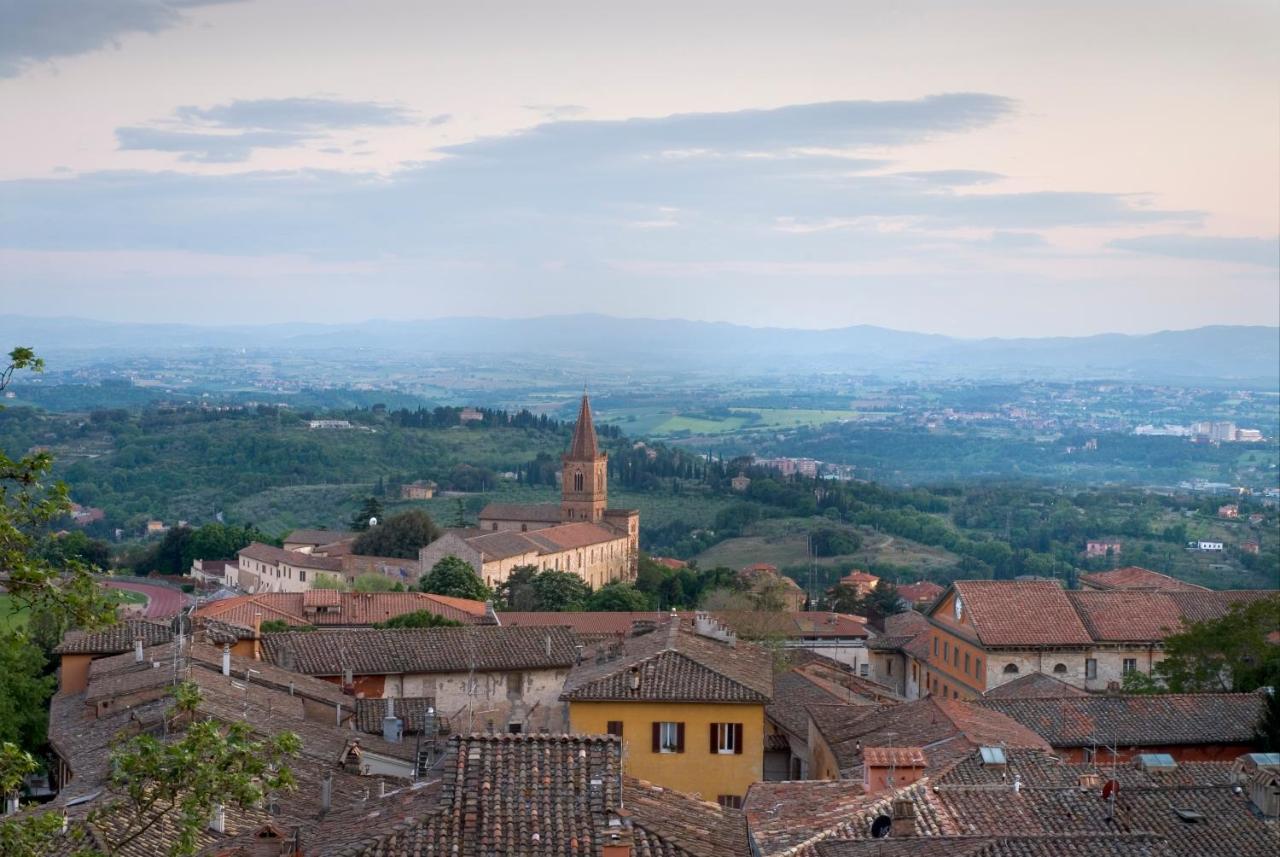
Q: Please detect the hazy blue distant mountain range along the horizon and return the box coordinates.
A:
[0,315,1280,388]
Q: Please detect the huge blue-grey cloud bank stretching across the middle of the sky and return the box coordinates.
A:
[0,95,1201,271]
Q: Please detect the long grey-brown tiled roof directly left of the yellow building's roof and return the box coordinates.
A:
[262,625,577,675]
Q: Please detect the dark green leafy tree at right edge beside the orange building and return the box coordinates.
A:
[1125,595,1280,693]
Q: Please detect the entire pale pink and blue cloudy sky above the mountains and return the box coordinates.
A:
[0,0,1280,336]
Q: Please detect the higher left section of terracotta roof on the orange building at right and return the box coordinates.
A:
[946,581,1093,646]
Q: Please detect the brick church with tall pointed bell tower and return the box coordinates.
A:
[419,394,640,590]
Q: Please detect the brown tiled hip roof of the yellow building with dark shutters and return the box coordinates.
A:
[561,623,773,704]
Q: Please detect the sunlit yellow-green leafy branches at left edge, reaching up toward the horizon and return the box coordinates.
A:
[0,347,115,628]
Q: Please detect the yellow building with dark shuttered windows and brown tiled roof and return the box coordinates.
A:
[561,614,773,807]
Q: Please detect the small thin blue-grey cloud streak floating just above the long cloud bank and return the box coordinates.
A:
[174,98,414,132]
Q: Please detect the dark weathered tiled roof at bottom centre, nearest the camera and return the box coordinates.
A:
[326,735,746,857]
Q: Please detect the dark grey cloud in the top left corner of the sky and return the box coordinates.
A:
[0,0,237,78]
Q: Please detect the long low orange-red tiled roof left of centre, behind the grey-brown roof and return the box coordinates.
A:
[192,590,484,628]
